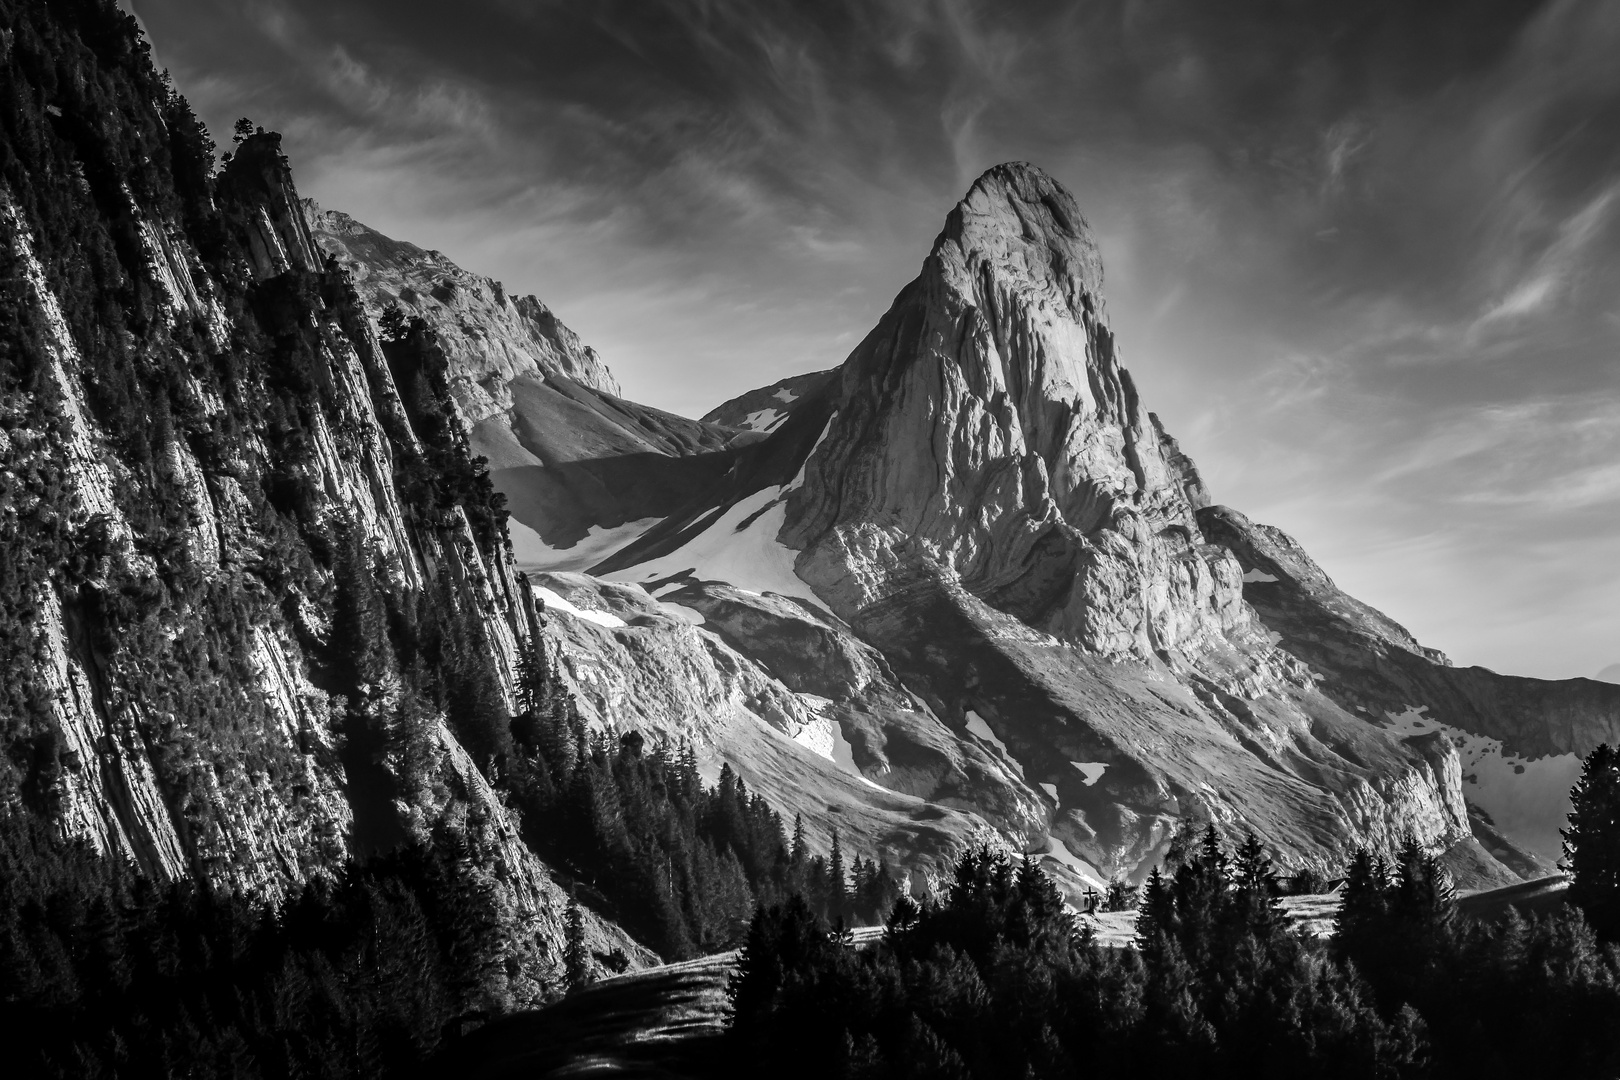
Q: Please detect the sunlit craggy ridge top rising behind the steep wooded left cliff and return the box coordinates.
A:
[300,199,619,423]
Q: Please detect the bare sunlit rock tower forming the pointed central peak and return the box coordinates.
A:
[782,165,1247,657]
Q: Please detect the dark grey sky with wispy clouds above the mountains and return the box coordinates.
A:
[130,0,1620,683]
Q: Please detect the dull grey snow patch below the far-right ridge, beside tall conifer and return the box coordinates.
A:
[1383,704,1581,863]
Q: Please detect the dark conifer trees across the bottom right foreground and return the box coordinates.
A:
[729,746,1620,1080]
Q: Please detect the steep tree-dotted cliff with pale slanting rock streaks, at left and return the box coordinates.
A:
[0,3,645,1001]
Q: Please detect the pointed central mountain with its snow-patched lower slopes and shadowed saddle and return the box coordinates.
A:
[332,164,1620,891]
